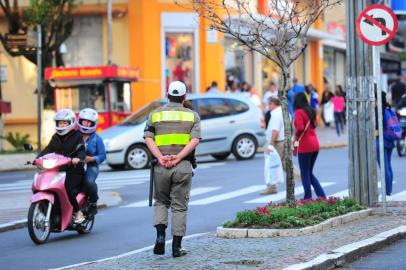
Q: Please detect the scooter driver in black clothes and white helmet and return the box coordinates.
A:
[37,109,86,223]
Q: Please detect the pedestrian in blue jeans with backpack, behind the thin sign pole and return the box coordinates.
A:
[375,92,401,196]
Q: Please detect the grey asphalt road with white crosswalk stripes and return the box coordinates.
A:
[0,148,406,270]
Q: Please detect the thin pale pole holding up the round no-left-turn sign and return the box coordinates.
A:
[373,46,386,210]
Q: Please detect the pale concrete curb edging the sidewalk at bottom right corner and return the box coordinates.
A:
[283,226,406,270]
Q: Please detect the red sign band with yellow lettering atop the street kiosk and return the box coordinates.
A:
[45,66,139,81]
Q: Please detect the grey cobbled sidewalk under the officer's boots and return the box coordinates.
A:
[58,205,406,270]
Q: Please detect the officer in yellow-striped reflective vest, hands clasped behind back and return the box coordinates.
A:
[144,81,200,257]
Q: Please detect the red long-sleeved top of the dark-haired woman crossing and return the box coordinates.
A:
[294,109,320,153]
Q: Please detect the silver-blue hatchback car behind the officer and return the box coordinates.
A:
[100,94,266,169]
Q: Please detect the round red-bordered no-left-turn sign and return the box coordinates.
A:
[356,5,398,46]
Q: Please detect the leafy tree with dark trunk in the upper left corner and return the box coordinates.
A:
[0,0,75,104]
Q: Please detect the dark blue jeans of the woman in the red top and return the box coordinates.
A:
[298,152,326,199]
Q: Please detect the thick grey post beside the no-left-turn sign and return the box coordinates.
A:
[346,0,378,206]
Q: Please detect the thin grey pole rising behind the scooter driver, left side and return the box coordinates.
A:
[37,24,42,153]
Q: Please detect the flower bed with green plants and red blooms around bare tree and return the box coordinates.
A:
[223,197,365,229]
